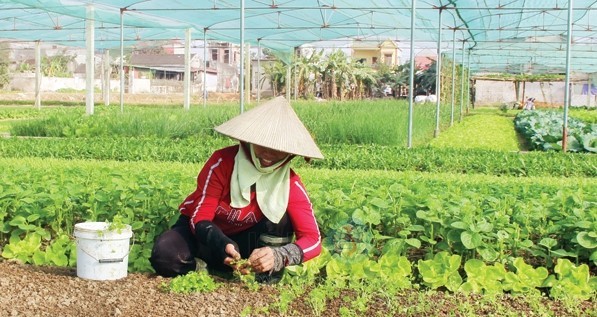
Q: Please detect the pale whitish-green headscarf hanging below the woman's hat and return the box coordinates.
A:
[230,144,290,223]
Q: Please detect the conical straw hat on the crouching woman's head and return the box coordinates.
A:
[215,97,323,159]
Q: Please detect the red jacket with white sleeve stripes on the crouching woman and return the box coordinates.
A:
[179,145,321,261]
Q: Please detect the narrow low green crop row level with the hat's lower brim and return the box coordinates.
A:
[0,137,597,177]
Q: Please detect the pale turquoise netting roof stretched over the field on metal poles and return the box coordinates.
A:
[0,0,597,73]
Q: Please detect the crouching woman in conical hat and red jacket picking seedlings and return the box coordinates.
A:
[150,97,323,277]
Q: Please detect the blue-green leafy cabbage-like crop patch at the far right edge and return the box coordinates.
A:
[514,111,597,153]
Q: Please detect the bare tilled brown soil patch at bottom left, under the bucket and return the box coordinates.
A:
[0,261,286,317]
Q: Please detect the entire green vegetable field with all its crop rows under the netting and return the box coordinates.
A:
[0,100,597,316]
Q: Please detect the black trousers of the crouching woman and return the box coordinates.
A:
[149,214,294,277]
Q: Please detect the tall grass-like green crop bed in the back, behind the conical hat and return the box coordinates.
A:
[10,100,447,145]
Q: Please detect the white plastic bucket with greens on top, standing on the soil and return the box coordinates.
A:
[74,222,133,280]
